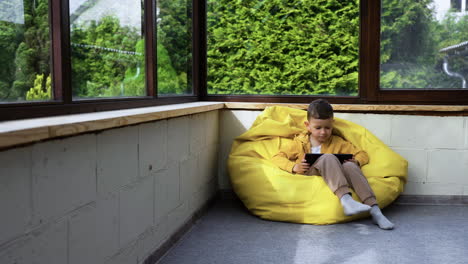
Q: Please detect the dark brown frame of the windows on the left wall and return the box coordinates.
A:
[0,0,202,121]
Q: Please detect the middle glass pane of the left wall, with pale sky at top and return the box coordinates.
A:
[70,0,146,99]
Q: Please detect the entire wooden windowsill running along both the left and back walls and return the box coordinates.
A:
[0,101,468,149]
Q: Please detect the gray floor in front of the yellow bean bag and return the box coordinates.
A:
[158,200,468,264]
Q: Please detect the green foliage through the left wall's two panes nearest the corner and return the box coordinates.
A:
[71,0,192,97]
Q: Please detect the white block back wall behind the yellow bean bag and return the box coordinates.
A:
[218,110,468,195]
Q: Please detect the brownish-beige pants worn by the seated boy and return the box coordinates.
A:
[306,154,377,206]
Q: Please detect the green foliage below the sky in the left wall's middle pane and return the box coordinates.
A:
[71,16,146,98]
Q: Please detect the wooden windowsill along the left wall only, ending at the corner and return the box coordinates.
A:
[0,102,224,149]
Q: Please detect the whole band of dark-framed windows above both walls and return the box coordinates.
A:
[0,0,468,120]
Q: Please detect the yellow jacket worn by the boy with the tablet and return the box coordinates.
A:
[271,132,369,173]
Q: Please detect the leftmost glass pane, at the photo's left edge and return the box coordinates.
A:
[0,0,52,102]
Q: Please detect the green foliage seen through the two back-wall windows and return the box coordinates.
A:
[207,0,468,95]
